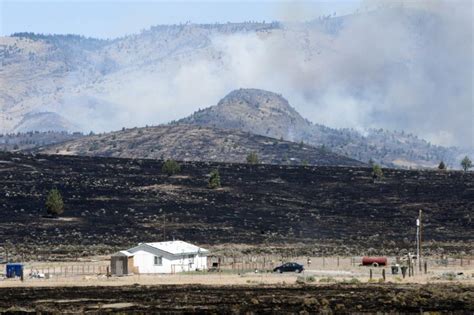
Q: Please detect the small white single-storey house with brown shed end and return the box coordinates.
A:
[111,241,209,275]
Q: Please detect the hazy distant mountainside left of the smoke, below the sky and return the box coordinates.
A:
[0,23,280,133]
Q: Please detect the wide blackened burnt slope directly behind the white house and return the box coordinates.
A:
[0,153,474,258]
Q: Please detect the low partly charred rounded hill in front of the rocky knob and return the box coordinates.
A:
[39,124,364,166]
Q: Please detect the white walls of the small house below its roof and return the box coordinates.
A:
[133,250,207,274]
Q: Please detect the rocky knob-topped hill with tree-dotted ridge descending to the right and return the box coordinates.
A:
[178,89,460,168]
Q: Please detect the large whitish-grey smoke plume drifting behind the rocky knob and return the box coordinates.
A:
[55,1,474,148]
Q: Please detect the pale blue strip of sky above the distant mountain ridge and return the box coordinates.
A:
[0,0,361,38]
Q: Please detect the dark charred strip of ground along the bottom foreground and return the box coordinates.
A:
[0,284,474,314]
